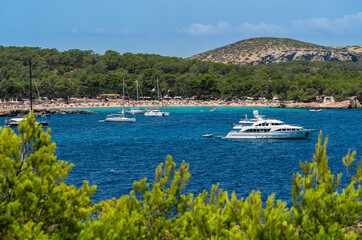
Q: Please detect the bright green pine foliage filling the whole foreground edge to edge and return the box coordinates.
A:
[0,115,362,239]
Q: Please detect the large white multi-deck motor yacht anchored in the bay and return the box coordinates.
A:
[225,110,317,139]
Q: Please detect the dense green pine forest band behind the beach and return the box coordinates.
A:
[0,46,362,101]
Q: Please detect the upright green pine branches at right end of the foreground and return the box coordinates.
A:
[291,134,362,239]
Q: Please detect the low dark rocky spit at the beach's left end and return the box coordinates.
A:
[0,109,94,117]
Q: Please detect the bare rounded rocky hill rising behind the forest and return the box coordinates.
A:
[190,37,362,65]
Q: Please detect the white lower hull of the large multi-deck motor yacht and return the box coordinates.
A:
[225,129,317,139]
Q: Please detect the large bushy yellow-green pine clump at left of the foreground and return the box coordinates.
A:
[0,113,95,239]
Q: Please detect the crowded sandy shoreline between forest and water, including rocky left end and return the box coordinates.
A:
[0,98,362,117]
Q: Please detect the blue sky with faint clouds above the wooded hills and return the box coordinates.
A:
[0,0,362,58]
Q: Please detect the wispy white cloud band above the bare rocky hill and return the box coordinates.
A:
[175,12,362,38]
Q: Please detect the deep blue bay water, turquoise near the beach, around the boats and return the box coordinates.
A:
[3,107,362,205]
